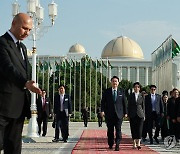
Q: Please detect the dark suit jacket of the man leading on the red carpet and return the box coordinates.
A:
[101,88,127,119]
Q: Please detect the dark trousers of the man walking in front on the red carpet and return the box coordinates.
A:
[106,113,122,146]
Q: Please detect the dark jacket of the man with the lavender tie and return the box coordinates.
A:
[54,94,72,116]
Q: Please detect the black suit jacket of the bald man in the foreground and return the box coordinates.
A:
[0,33,31,118]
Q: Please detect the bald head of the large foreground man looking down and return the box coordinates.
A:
[10,13,32,40]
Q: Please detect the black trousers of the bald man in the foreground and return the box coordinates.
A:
[0,116,24,154]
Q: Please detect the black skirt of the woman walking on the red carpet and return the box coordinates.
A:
[130,115,144,139]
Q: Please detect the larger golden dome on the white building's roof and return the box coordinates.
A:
[101,36,144,59]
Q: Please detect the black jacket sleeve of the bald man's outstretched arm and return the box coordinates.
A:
[0,39,27,89]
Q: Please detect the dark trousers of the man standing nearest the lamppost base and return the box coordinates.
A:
[37,111,48,136]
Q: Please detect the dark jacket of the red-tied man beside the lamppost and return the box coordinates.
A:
[36,96,51,116]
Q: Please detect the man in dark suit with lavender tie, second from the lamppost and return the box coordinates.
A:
[52,85,72,142]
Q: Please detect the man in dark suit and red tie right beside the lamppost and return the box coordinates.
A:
[36,90,51,136]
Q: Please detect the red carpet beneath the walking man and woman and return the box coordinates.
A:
[72,130,158,154]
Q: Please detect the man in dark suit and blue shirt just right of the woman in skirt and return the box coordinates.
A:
[145,85,163,144]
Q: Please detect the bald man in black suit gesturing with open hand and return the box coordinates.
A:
[0,13,41,154]
